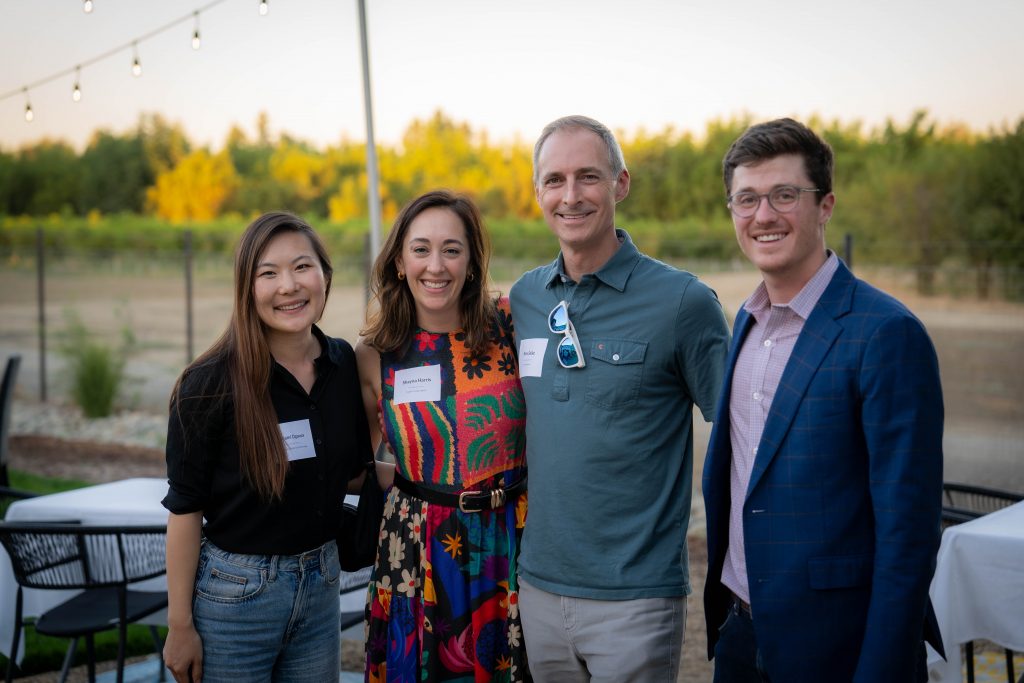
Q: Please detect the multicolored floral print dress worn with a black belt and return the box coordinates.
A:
[367,299,527,682]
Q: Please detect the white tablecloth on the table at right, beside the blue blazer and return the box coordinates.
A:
[928,502,1024,683]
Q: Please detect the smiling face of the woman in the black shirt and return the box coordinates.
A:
[253,230,327,338]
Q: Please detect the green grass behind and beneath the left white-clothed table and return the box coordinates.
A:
[0,470,167,676]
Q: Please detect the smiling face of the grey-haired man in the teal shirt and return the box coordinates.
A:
[535,128,630,258]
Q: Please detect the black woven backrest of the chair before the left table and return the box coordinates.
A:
[0,522,167,589]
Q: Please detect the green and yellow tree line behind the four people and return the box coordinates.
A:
[0,111,1024,293]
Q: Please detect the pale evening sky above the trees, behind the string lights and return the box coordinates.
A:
[0,0,1024,152]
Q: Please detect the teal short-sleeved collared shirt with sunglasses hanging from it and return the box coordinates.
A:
[511,230,729,600]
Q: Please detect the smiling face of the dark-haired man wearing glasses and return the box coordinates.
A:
[729,155,836,303]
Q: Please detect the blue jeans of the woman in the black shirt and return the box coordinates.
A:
[193,541,341,683]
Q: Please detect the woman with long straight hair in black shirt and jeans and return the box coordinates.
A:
[157,213,372,683]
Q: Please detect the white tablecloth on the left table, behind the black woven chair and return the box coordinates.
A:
[0,478,167,659]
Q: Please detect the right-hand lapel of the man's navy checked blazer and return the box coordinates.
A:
[746,261,856,498]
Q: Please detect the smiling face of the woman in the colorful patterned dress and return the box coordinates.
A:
[395,207,471,332]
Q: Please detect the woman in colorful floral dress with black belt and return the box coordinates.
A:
[355,190,528,682]
